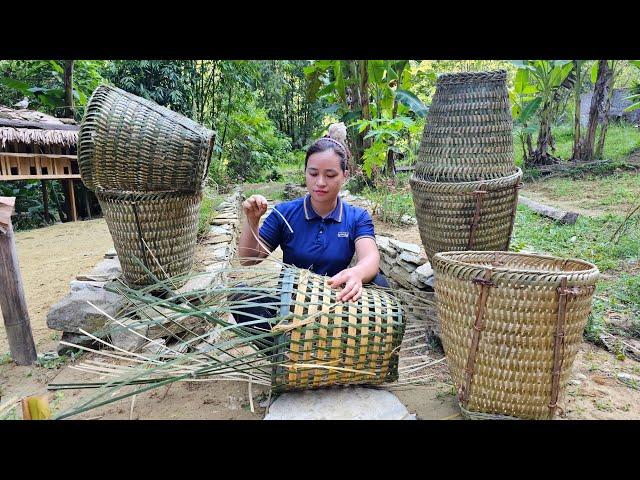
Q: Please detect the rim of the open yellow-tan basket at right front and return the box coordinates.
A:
[432,250,600,275]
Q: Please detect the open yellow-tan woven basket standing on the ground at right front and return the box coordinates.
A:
[431,251,599,419]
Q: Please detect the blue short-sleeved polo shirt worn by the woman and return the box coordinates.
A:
[260,194,375,277]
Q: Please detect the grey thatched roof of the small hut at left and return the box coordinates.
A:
[0,105,78,149]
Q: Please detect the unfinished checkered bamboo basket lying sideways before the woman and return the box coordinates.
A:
[272,267,405,391]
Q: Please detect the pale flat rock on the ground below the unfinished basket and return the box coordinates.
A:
[264,387,416,420]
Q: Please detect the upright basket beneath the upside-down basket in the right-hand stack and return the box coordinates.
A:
[409,169,522,259]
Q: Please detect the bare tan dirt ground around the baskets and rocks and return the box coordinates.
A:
[0,188,640,420]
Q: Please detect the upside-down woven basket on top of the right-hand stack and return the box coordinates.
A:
[414,70,515,182]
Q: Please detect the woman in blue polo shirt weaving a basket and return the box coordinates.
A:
[236,123,389,330]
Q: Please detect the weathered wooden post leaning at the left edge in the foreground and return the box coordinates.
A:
[0,197,37,365]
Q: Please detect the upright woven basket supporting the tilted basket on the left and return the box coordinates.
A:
[96,191,202,286]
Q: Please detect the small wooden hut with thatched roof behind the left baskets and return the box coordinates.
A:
[0,105,99,221]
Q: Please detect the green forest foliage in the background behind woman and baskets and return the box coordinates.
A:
[0,60,640,229]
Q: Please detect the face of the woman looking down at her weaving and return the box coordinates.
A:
[305,149,349,203]
